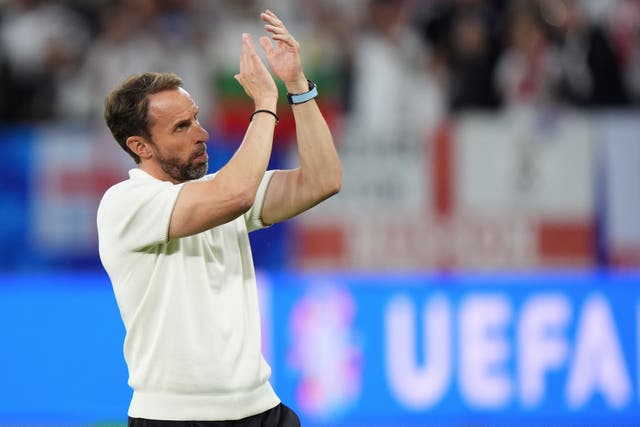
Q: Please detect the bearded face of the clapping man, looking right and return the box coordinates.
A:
[149,88,209,183]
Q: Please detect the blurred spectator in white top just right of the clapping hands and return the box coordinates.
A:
[350,0,441,143]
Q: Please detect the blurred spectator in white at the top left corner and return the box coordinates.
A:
[0,0,89,122]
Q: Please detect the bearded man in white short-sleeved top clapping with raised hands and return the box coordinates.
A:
[97,10,342,427]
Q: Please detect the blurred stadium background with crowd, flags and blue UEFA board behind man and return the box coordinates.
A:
[0,0,640,427]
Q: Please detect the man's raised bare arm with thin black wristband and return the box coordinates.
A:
[169,34,278,238]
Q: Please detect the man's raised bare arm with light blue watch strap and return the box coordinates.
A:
[260,10,342,224]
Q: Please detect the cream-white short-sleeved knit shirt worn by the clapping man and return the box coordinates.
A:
[97,169,280,421]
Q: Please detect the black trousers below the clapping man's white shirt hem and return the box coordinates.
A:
[129,403,300,427]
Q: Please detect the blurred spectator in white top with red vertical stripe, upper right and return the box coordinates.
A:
[495,1,559,107]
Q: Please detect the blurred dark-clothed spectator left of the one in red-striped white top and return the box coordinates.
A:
[420,0,502,112]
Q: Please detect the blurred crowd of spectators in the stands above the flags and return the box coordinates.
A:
[0,0,640,124]
